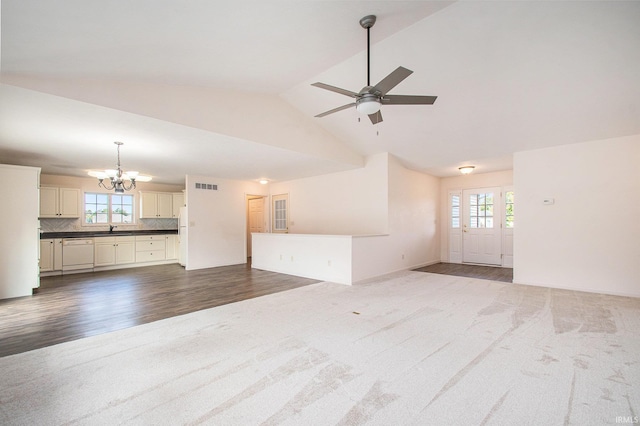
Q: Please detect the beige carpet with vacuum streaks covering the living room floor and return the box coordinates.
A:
[0,272,640,425]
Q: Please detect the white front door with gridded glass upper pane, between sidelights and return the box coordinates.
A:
[462,188,502,265]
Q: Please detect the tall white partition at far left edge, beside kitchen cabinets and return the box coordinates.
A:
[0,164,40,299]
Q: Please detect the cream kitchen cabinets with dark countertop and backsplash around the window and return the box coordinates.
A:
[39,184,185,276]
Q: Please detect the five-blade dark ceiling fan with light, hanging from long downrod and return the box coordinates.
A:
[312,15,437,124]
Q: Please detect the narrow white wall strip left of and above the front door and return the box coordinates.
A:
[439,170,520,262]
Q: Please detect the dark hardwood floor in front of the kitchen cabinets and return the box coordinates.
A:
[0,264,318,357]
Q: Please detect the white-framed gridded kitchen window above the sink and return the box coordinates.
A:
[84,192,134,225]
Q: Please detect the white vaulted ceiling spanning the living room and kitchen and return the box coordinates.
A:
[0,0,640,183]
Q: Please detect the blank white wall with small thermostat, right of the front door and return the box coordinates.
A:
[514,135,640,297]
